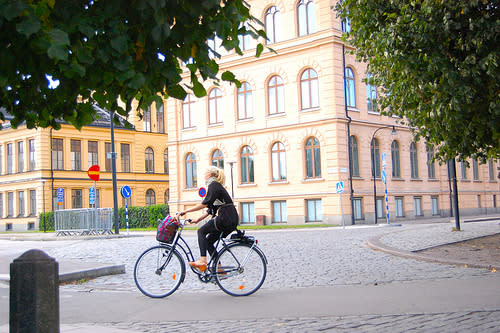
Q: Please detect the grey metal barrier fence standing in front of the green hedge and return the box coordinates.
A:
[54,208,113,236]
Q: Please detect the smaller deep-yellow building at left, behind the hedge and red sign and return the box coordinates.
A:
[0,106,168,231]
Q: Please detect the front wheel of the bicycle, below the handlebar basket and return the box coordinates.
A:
[134,245,186,298]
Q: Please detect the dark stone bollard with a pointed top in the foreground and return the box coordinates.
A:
[10,250,59,333]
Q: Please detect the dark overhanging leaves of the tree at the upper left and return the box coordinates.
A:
[0,0,265,128]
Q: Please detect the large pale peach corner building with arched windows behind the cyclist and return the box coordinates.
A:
[167,0,500,224]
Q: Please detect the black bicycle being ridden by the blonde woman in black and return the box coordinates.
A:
[134,219,267,298]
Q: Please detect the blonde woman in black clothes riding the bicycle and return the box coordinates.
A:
[179,166,239,272]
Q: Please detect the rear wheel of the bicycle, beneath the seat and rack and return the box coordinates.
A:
[214,243,267,296]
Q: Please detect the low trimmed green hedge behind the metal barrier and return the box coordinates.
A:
[39,204,170,231]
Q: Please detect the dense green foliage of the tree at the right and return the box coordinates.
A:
[336,0,500,160]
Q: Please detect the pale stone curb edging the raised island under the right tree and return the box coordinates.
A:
[366,234,500,270]
